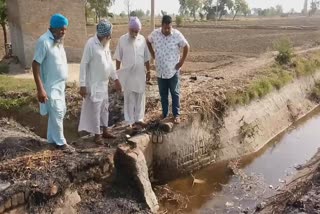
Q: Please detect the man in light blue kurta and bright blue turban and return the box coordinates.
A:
[32,14,75,153]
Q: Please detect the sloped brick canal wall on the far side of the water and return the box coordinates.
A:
[151,71,320,180]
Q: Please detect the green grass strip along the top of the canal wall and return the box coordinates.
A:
[227,52,320,106]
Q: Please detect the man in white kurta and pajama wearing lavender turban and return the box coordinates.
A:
[114,17,151,127]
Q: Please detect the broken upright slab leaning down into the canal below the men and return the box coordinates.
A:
[114,144,159,213]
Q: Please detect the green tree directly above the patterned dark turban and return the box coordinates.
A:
[87,0,114,22]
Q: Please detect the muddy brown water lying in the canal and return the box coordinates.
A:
[165,108,320,213]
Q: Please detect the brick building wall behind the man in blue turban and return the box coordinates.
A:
[7,0,87,67]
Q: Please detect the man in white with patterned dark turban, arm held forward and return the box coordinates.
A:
[79,20,121,144]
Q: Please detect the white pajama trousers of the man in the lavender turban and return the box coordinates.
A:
[124,90,146,125]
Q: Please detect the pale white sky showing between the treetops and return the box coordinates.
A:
[111,0,304,14]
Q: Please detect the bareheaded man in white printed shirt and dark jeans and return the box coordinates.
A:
[147,15,190,124]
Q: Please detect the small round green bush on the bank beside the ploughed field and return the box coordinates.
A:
[274,39,294,65]
